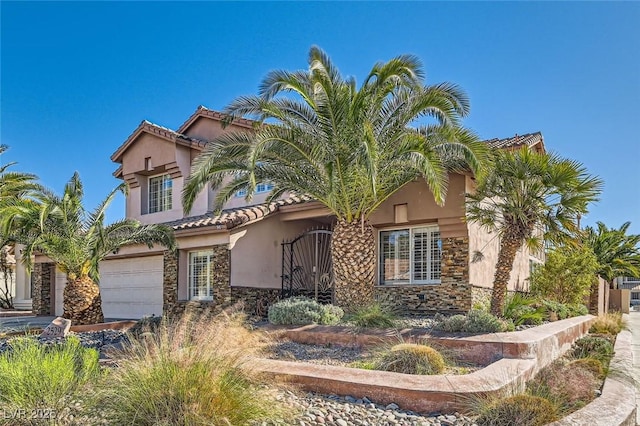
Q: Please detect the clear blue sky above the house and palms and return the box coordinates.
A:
[0,1,640,233]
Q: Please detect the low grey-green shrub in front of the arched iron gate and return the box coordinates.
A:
[269,297,344,325]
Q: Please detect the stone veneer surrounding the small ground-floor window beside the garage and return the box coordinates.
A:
[162,244,231,316]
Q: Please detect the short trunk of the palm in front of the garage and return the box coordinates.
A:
[64,277,104,325]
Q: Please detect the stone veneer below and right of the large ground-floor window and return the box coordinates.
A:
[376,237,472,315]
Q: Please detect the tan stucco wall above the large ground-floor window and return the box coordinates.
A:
[369,174,467,238]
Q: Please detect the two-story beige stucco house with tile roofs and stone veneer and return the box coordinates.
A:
[33,107,544,318]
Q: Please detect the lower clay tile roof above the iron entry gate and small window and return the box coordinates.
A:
[166,195,312,231]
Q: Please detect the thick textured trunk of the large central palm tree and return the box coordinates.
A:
[331,221,376,310]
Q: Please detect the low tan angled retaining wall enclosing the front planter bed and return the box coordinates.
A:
[256,315,594,413]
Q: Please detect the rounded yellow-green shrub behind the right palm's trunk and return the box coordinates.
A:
[530,247,599,306]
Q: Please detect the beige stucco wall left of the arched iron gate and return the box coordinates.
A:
[231,215,317,288]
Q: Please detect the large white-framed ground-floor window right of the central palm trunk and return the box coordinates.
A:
[379,226,442,285]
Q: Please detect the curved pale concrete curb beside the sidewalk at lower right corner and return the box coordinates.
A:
[552,330,636,426]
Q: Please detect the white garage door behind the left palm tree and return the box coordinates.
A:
[100,256,163,318]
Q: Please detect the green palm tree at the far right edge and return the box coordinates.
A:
[583,222,640,288]
